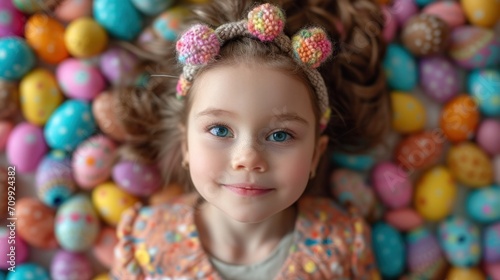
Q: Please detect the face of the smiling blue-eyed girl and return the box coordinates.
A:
[183,63,328,223]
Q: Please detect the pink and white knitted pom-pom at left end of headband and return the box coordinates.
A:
[176,24,220,65]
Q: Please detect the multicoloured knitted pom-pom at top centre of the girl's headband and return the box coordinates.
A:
[248,3,285,41]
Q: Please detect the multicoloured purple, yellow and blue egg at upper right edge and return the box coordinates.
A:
[449,25,500,69]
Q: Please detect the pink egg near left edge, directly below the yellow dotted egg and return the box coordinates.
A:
[7,122,48,173]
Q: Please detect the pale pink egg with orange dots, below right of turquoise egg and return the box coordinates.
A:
[71,135,116,189]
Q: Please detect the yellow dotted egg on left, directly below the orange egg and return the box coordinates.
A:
[19,68,63,125]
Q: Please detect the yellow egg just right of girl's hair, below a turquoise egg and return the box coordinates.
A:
[391,91,425,134]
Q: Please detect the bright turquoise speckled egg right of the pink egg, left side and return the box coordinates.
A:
[44,100,96,151]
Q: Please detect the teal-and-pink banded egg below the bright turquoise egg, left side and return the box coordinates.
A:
[35,150,76,208]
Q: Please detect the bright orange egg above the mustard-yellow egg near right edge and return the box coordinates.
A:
[439,95,479,142]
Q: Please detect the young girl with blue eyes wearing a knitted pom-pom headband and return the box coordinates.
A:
[111,1,385,280]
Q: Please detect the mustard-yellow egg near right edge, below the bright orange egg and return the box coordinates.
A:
[447,142,493,187]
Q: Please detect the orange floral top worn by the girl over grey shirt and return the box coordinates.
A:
[111,196,380,280]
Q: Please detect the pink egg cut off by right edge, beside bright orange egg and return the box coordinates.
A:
[476,119,500,155]
